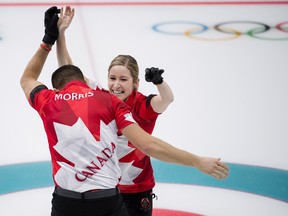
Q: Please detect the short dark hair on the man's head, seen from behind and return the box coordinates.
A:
[51,65,85,89]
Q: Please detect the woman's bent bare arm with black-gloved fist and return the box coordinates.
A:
[145,67,174,113]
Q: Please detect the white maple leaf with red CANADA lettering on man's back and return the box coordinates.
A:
[54,118,120,192]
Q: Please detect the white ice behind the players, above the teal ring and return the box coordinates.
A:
[0,0,288,169]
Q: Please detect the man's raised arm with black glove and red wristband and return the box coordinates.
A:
[20,6,60,99]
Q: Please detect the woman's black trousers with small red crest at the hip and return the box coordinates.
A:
[123,190,155,216]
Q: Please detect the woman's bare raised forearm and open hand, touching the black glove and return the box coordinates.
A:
[56,6,75,67]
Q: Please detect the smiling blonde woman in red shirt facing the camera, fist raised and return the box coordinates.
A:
[108,55,174,216]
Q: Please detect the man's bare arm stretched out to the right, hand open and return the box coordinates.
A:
[122,124,229,180]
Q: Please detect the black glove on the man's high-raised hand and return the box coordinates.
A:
[42,6,60,45]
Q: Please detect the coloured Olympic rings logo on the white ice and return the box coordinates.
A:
[152,21,288,41]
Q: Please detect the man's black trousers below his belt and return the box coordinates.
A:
[51,192,127,216]
